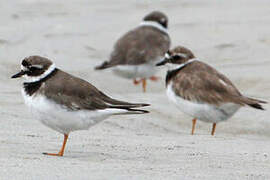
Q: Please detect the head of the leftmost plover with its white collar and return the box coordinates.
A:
[11,56,55,82]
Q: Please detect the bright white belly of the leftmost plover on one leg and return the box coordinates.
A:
[22,90,123,134]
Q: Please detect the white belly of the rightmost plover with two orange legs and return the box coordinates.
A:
[167,83,240,123]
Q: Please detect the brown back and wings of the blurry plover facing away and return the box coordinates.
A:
[96,26,170,69]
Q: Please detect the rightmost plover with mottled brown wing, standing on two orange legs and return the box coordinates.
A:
[157,46,266,135]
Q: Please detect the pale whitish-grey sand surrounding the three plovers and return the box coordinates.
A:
[0,0,270,180]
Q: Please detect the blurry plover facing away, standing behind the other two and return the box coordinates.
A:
[95,11,171,92]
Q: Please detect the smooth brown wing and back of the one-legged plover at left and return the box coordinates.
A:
[40,70,148,111]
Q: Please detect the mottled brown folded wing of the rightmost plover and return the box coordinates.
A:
[172,62,245,105]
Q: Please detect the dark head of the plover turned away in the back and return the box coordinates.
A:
[143,11,168,28]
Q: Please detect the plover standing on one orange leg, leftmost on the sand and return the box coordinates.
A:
[12,56,148,156]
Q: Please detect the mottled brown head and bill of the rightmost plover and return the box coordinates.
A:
[156,46,195,66]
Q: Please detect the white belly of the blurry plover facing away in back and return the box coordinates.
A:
[113,61,158,79]
